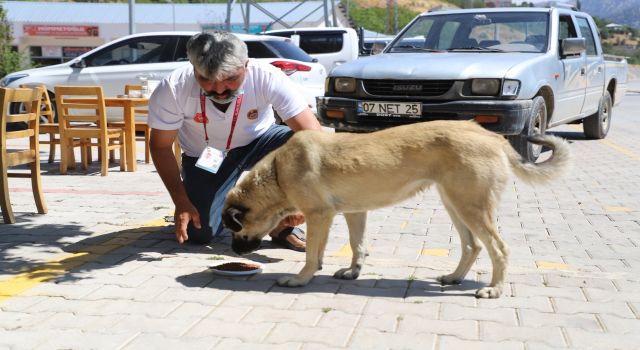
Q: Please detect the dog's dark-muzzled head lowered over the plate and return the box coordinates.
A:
[222,154,292,254]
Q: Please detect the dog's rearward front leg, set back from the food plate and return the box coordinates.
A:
[333,211,367,280]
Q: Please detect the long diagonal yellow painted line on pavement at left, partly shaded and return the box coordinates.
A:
[0,219,168,302]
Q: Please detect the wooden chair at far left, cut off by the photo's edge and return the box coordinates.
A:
[0,88,47,224]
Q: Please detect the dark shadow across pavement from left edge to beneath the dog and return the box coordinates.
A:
[0,217,484,298]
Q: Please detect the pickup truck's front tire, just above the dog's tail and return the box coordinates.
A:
[507,96,547,163]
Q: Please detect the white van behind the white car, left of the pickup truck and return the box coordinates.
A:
[262,27,360,72]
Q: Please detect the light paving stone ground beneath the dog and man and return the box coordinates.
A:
[0,85,640,350]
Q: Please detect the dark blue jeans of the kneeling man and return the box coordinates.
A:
[182,125,293,244]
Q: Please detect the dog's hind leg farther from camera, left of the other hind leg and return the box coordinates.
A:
[437,191,482,285]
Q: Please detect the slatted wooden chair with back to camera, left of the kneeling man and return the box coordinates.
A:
[54,86,125,176]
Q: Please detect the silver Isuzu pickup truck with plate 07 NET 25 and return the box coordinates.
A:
[317,8,627,161]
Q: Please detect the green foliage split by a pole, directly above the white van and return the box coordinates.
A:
[349,1,419,35]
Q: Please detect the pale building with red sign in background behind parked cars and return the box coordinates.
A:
[0,1,331,65]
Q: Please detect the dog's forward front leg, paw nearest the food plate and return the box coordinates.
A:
[278,213,335,287]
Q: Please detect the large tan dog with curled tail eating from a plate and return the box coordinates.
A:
[223,121,569,298]
